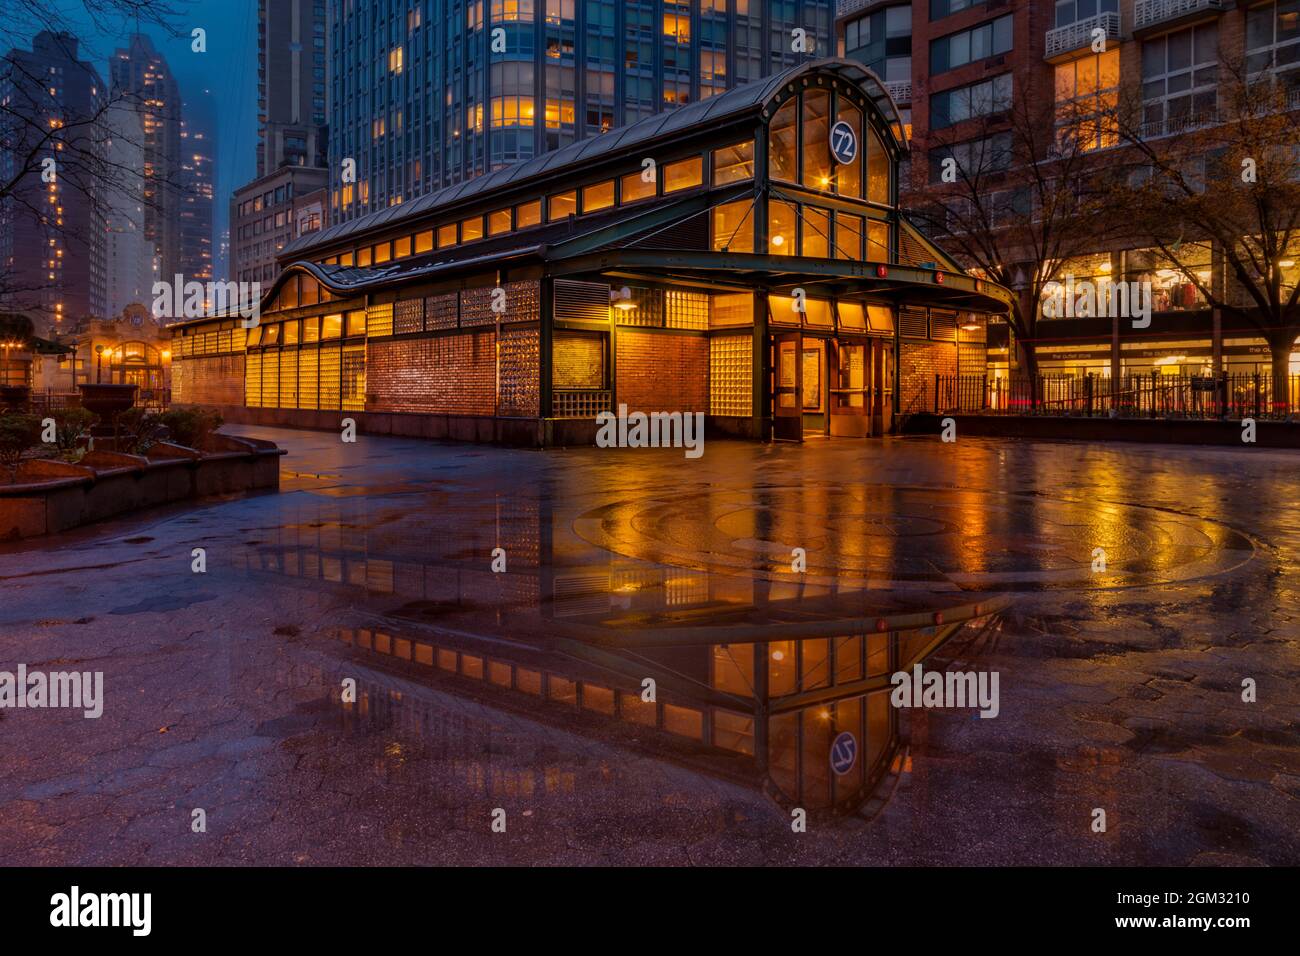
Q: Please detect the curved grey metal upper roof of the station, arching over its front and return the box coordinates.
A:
[282,57,907,261]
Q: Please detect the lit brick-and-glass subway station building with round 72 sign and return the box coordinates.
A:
[172,59,1010,445]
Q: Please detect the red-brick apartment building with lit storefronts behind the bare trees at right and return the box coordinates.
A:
[836,0,1300,377]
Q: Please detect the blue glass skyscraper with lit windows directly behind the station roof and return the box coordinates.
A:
[329,0,832,221]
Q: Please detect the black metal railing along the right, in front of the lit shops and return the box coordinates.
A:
[932,372,1300,419]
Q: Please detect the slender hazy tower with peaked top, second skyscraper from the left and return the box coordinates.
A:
[112,34,185,283]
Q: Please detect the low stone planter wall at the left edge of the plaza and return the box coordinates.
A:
[0,434,285,541]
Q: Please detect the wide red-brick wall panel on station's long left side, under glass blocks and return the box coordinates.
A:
[365,330,497,415]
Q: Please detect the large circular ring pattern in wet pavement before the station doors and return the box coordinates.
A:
[573,483,1255,591]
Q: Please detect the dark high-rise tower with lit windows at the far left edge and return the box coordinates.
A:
[0,31,107,332]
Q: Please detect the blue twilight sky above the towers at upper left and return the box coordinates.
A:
[24,0,257,277]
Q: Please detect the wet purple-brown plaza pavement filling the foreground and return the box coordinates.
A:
[0,427,1300,865]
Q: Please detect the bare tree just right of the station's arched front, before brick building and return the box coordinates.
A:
[910,77,1115,377]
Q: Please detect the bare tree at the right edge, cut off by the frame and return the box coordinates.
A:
[1115,61,1300,414]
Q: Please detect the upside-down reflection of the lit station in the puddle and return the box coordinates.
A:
[241,502,1002,810]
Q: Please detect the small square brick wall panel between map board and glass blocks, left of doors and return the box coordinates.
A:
[615,328,709,412]
